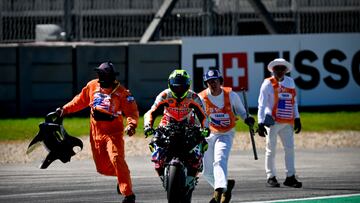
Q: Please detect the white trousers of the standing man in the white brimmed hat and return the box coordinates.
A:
[265,123,295,178]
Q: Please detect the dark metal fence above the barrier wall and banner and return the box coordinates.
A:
[0,0,360,43]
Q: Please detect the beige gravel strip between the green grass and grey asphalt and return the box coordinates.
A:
[0,131,360,164]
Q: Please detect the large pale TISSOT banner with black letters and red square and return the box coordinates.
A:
[181,33,360,107]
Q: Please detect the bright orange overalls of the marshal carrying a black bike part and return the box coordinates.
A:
[63,79,139,196]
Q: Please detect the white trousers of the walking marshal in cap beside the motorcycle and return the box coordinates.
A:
[203,130,235,190]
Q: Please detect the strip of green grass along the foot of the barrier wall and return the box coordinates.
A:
[0,111,360,141]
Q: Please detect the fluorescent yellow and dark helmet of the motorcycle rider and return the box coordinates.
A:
[168,70,191,99]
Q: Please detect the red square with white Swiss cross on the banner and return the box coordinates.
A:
[222,53,248,91]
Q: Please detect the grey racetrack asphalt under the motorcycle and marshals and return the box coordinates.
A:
[0,148,360,203]
